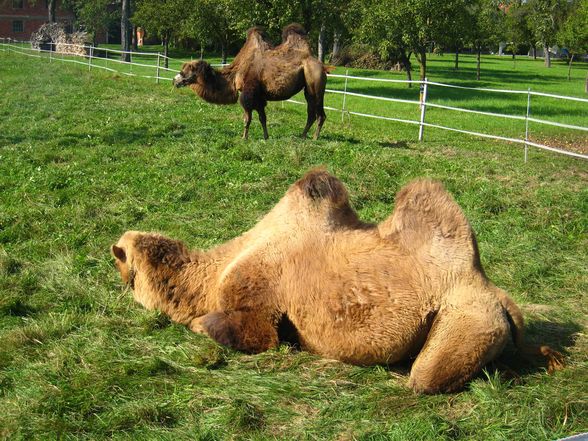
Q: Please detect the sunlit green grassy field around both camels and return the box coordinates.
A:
[0,46,588,441]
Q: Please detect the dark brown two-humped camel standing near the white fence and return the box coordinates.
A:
[174,23,329,139]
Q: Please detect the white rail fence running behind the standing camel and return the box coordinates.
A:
[0,38,588,162]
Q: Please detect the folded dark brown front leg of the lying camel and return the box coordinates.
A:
[199,310,279,354]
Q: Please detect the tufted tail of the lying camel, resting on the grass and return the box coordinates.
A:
[496,288,565,374]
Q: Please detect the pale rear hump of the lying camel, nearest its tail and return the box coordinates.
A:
[378,179,483,274]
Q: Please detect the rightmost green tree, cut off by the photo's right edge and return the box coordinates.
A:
[557,0,588,83]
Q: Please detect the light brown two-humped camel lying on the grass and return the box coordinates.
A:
[112,170,560,393]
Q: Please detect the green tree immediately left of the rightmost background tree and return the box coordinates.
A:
[528,0,568,67]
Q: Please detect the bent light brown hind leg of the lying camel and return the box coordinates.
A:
[409,309,510,394]
